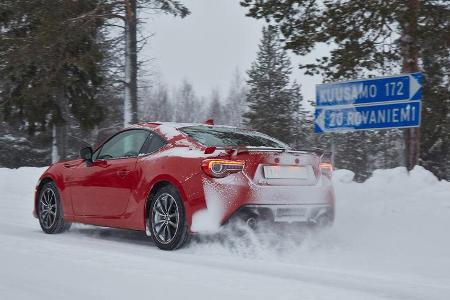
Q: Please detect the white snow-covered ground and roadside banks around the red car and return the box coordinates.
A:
[0,168,450,300]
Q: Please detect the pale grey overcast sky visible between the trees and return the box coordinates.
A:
[142,0,321,100]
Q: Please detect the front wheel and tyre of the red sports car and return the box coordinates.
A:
[37,182,72,234]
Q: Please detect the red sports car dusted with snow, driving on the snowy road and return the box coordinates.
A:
[33,123,335,250]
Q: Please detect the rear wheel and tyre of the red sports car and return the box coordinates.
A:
[148,186,190,250]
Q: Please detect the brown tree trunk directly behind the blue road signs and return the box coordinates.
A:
[400,0,420,170]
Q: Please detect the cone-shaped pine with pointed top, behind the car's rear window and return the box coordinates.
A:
[244,26,299,143]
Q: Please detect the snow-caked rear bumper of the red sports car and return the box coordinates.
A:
[204,174,335,224]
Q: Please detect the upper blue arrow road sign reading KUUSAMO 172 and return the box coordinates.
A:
[316,73,422,107]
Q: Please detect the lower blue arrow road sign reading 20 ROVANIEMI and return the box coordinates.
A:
[314,101,421,133]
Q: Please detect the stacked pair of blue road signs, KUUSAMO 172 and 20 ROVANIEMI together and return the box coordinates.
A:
[314,73,422,133]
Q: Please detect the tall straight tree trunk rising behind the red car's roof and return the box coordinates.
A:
[123,0,138,126]
